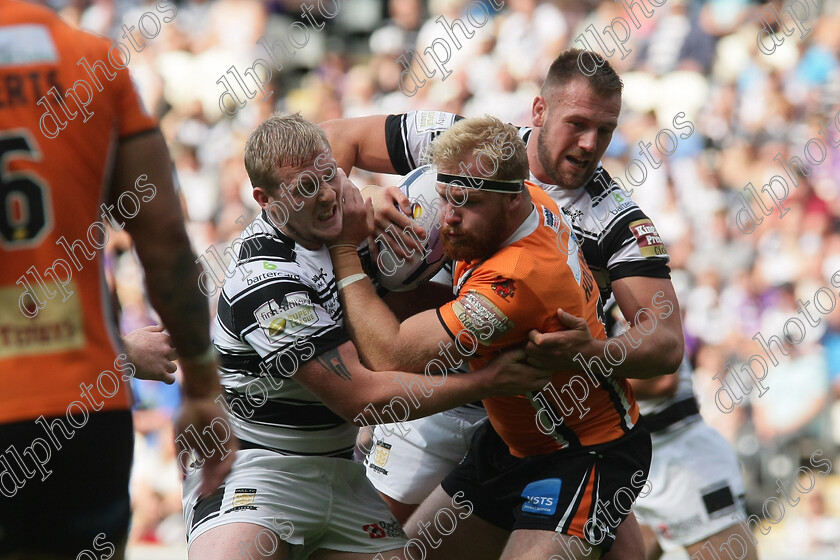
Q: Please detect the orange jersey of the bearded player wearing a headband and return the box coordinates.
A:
[438,186,639,457]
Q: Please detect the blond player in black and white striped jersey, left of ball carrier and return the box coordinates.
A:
[184,114,548,560]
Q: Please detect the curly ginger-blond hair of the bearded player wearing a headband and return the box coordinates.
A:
[429,115,530,181]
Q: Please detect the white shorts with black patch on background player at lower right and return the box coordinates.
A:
[633,420,746,551]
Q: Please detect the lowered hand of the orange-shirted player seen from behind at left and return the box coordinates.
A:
[175,378,238,496]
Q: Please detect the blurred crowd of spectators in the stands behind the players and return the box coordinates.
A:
[46,0,840,557]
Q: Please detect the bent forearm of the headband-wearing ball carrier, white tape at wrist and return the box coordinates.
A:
[330,247,423,371]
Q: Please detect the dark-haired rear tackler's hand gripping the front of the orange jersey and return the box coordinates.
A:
[525,309,595,371]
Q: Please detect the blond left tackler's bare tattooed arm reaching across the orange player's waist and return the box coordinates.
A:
[294,342,550,426]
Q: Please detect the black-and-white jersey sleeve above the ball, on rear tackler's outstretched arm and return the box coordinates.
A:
[385,111,464,175]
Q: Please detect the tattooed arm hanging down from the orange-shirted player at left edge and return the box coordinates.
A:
[112,131,235,495]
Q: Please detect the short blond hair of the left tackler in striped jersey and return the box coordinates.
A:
[245,113,330,193]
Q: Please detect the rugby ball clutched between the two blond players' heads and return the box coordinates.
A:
[373,165,446,292]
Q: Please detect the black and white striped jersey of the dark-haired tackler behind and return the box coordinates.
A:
[385,111,670,302]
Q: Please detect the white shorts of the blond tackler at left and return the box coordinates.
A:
[183,449,408,560]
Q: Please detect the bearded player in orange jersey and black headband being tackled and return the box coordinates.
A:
[330,117,650,559]
